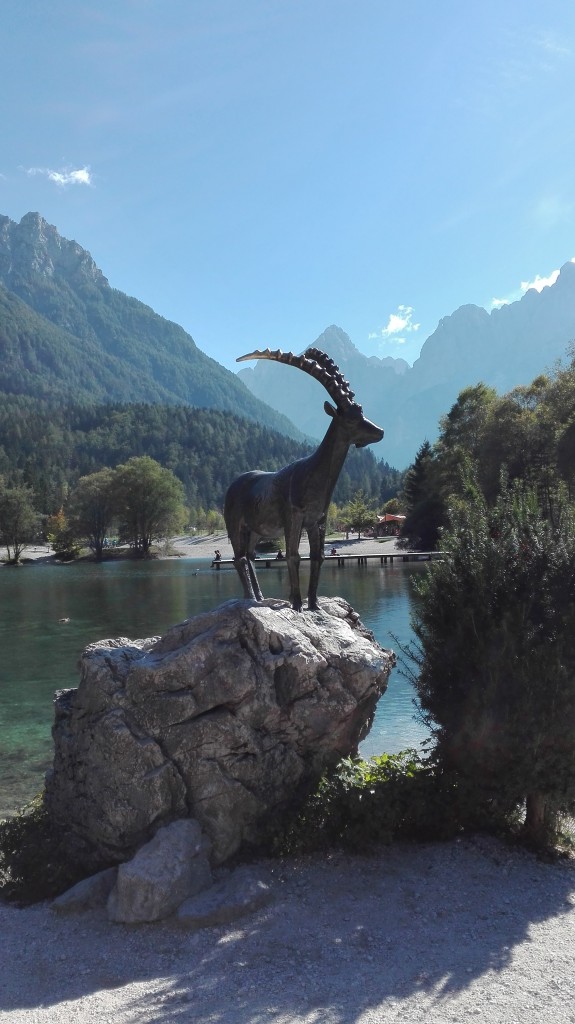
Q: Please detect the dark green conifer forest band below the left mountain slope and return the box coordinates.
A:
[0,395,399,514]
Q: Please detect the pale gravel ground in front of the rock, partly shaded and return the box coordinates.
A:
[0,838,575,1024]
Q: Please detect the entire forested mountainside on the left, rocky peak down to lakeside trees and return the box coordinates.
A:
[0,213,399,515]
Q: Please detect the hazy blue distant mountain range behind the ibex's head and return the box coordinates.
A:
[239,262,575,469]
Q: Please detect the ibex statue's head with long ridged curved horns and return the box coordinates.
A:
[236,348,384,447]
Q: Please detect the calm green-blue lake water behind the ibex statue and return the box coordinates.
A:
[0,558,427,817]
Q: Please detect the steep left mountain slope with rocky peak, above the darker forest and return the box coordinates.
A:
[0,213,302,438]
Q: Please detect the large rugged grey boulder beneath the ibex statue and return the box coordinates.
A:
[46,598,394,870]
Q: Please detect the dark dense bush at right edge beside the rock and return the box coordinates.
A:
[413,482,575,844]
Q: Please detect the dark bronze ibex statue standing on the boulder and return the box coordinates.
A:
[224,348,384,611]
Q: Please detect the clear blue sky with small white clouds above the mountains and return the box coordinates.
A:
[0,0,575,369]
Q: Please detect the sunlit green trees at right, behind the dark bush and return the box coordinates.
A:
[402,359,575,550]
